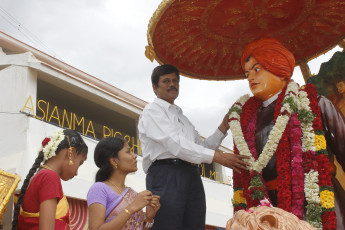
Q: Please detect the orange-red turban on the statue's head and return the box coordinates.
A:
[241,38,295,79]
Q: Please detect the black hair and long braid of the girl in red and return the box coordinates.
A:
[12,129,88,230]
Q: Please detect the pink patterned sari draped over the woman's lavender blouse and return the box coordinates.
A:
[105,188,145,230]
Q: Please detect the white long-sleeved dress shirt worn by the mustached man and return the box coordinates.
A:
[138,98,226,173]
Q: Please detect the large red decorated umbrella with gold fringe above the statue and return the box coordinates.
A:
[145,0,345,80]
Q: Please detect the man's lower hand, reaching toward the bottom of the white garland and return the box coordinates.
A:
[213,150,250,173]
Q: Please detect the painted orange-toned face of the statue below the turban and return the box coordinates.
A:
[244,57,287,101]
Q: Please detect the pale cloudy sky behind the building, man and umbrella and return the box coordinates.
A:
[0,0,340,149]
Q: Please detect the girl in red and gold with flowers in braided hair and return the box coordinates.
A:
[12,129,88,230]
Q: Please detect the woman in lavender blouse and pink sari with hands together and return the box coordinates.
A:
[87,137,160,230]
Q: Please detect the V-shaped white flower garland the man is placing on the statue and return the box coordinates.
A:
[229,81,298,173]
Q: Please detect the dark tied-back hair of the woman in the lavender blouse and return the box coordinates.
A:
[94,137,125,182]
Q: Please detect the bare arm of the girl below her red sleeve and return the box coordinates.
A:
[39,198,58,230]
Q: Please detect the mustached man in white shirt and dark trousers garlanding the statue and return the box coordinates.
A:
[138,65,247,230]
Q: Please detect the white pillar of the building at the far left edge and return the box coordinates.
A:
[0,52,37,173]
